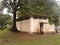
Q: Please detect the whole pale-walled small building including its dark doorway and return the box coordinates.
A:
[16,17,56,34]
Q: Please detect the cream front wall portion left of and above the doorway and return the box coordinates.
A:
[33,18,49,33]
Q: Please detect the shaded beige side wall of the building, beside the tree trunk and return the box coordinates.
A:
[16,19,31,33]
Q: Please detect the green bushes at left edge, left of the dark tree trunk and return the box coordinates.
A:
[0,14,12,29]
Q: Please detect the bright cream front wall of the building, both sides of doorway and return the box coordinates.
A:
[31,18,56,33]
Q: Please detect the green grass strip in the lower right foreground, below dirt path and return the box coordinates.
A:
[4,36,60,45]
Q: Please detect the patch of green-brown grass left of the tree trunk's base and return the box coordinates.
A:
[0,30,17,39]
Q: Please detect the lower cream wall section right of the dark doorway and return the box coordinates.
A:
[43,23,56,33]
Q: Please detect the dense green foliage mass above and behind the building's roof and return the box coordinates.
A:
[18,0,57,16]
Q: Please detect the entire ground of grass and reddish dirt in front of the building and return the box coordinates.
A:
[0,31,60,45]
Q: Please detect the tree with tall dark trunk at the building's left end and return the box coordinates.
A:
[3,0,25,32]
